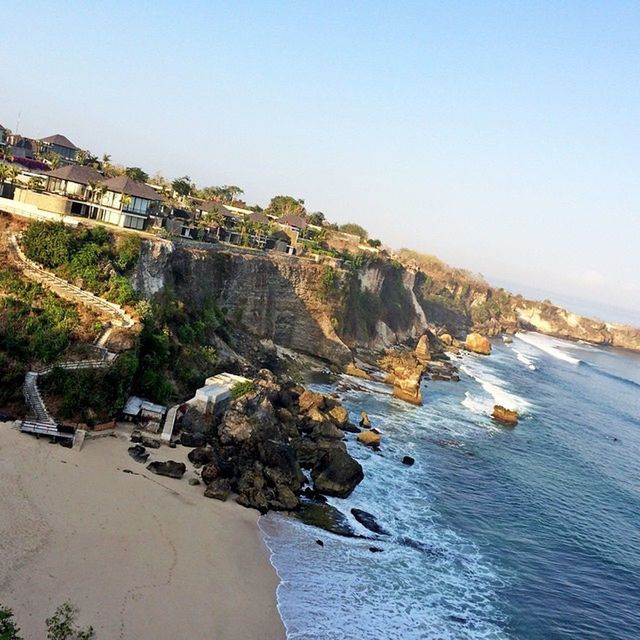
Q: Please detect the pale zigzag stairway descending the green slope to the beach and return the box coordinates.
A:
[10,235,137,436]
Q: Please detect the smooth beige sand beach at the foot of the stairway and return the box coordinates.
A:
[0,423,285,640]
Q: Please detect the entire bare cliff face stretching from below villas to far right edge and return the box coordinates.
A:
[134,241,640,365]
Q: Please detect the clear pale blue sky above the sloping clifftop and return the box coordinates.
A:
[0,0,640,321]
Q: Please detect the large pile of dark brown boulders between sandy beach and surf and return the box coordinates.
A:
[180,370,364,512]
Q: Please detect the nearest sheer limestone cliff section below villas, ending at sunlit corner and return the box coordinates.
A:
[135,243,351,364]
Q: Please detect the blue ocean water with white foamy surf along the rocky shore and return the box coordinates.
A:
[261,334,640,640]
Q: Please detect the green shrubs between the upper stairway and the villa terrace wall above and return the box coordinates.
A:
[21,222,141,304]
